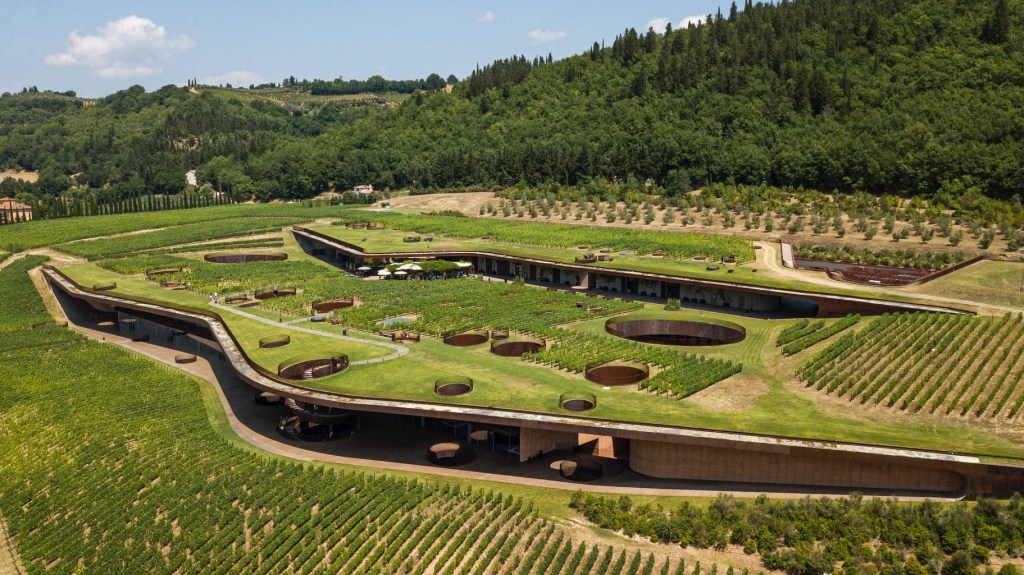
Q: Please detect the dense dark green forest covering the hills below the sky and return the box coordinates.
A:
[0,0,1024,212]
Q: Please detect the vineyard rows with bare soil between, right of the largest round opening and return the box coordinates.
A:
[799,313,1024,418]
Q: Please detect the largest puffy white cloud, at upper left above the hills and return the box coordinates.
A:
[45,15,195,78]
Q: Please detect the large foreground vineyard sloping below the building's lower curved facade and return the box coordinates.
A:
[0,252,676,575]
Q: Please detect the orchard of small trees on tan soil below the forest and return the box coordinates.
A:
[452,183,1024,254]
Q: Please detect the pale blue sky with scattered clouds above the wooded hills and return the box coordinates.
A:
[0,0,741,97]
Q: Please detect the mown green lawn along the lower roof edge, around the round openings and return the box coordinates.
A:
[61,264,1024,456]
